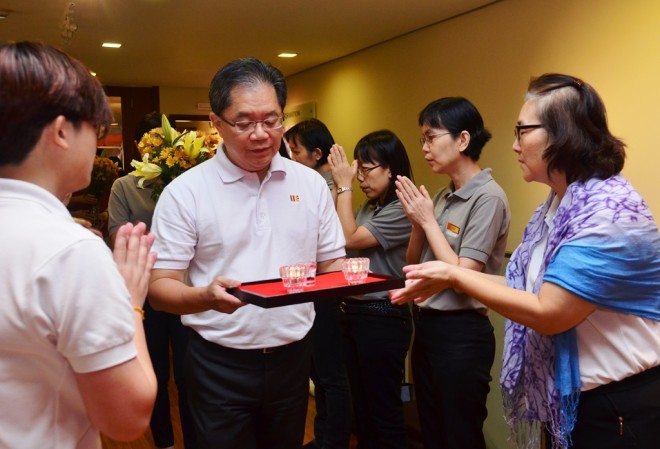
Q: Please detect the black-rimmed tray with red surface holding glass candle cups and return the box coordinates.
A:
[227,271,405,308]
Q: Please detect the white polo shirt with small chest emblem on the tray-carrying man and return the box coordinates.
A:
[152,151,345,349]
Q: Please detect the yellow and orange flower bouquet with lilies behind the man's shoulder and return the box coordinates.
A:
[129,114,220,201]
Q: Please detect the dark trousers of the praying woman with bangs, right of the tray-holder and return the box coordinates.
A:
[342,304,412,449]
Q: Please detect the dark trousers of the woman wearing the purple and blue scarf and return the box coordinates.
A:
[571,367,660,449]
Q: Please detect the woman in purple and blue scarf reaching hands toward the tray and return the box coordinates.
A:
[391,74,660,449]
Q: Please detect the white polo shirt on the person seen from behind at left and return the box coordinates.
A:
[0,179,136,448]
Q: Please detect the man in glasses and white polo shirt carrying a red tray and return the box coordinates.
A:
[149,58,345,449]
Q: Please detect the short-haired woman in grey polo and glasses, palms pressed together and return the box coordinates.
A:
[397,97,511,449]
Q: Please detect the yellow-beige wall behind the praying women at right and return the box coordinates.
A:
[288,0,660,448]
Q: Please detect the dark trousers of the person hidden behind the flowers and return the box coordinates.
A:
[144,301,196,449]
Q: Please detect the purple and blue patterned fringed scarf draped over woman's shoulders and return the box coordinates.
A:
[500,175,660,449]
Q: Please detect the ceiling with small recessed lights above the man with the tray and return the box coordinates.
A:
[0,0,498,88]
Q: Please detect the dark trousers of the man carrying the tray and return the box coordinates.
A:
[186,332,311,449]
